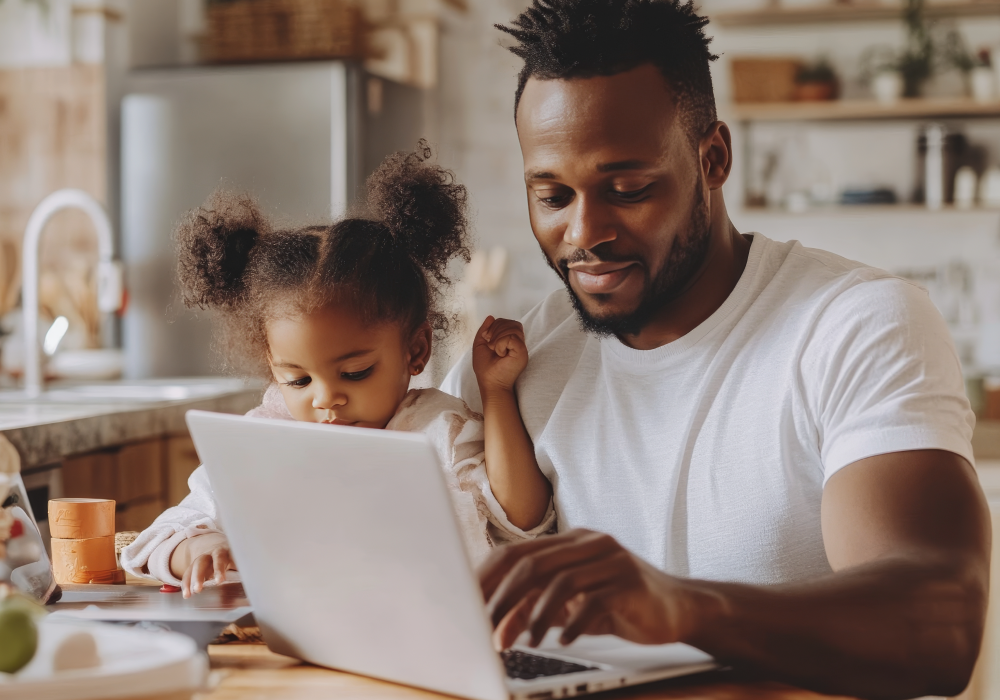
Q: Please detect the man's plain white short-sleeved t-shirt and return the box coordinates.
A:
[442,234,975,584]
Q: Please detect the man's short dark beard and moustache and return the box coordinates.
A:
[545,196,711,337]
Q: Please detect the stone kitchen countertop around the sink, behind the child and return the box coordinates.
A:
[0,377,264,470]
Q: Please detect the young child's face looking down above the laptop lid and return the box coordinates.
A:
[266,304,431,428]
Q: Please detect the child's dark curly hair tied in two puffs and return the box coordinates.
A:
[176,141,470,375]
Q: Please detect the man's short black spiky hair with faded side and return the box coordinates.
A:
[496,0,718,142]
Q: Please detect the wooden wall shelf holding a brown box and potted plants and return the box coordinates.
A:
[731,98,1000,121]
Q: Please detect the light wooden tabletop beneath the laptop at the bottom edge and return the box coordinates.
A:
[196,644,852,700]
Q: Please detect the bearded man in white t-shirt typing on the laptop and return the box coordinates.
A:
[445,0,990,697]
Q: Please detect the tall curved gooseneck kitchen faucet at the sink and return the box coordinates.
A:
[21,189,123,398]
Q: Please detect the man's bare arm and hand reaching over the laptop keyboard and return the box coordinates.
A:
[480,450,990,698]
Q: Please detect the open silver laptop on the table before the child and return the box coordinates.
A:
[187,411,717,700]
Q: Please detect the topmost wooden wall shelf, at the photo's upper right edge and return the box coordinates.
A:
[710,0,1000,27]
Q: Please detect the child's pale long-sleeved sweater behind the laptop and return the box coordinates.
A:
[121,384,555,586]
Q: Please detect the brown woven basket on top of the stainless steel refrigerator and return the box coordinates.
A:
[205,0,363,63]
